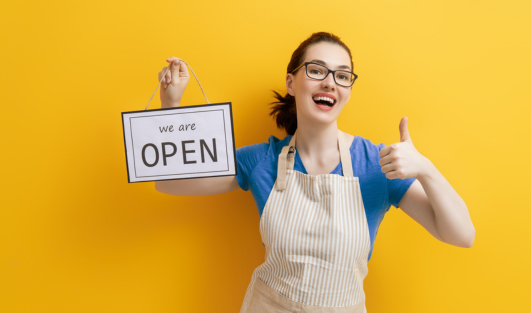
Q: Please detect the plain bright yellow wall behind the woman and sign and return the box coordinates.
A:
[0,0,531,313]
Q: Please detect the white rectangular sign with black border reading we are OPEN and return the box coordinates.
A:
[122,102,237,183]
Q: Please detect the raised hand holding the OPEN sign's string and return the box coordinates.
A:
[159,57,190,108]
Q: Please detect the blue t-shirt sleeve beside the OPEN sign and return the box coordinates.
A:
[236,143,269,191]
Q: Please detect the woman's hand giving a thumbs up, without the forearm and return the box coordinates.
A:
[378,117,430,179]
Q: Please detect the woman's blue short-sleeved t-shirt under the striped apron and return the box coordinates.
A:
[236,135,415,261]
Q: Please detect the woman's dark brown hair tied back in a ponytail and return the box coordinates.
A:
[269,32,354,135]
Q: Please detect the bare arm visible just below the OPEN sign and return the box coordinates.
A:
[155,176,240,196]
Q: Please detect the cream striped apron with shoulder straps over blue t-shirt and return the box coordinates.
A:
[240,131,370,313]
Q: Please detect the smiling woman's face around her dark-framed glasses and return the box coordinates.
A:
[286,42,352,126]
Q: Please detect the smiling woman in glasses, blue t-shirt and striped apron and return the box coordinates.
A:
[155,32,475,313]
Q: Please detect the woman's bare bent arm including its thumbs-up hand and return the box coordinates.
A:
[379,118,476,248]
